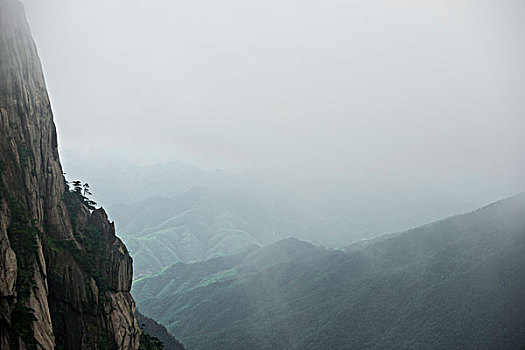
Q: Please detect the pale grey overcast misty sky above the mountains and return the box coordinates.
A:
[18,0,525,201]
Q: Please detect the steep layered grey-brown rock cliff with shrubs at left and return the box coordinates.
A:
[0,0,140,350]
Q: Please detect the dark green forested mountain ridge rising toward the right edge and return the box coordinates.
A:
[132,194,525,349]
